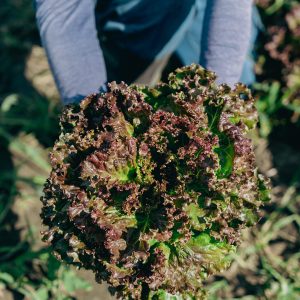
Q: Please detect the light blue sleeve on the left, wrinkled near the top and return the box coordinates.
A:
[35,0,106,104]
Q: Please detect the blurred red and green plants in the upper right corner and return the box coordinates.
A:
[254,0,300,137]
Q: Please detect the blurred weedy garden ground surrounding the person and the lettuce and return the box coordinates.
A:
[0,0,300,300]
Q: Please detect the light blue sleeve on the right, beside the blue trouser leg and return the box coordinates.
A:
[200,0,252,86]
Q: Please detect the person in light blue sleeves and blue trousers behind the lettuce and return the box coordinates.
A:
[35,0,255,104]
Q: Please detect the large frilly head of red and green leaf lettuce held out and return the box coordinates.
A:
[41,65,269,299]
